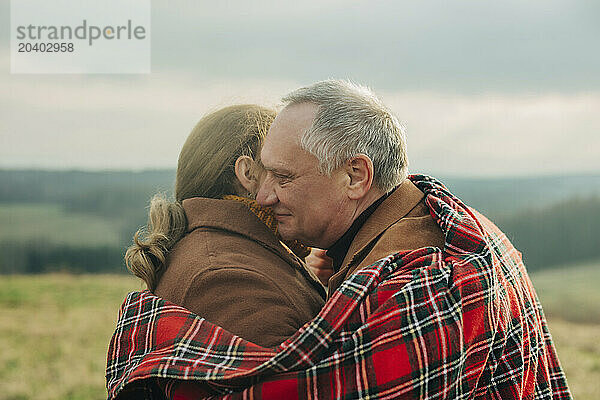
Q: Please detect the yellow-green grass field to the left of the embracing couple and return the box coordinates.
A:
[0,275,141,400]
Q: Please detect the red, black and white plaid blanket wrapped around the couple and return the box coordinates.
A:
[106,175,571,399]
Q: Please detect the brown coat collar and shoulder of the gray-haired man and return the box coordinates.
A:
[328,179,444,294]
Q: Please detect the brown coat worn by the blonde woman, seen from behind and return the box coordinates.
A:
[155,198,325,347]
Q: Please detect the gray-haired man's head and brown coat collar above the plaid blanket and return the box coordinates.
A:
[257,81,444,293]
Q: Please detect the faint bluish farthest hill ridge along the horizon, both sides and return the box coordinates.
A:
[0,170,600,218]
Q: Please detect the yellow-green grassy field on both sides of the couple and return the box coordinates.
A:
[0,263,600,400]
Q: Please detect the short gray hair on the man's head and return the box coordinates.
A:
[282,79,408,192]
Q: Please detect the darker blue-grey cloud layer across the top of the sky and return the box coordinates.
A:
[0,0,600,93]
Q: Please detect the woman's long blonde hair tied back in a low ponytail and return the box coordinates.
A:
[125,104,275,290]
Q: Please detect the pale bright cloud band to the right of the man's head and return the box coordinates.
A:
[382,92,600,176]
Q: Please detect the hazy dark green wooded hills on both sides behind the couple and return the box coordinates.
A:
[0,170,600,273]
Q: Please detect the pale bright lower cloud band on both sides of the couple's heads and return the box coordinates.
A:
[0,67,600,175]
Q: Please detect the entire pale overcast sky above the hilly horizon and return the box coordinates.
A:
[0,0,600,175]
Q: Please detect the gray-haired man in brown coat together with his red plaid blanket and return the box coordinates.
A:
[107,81,571,400]
